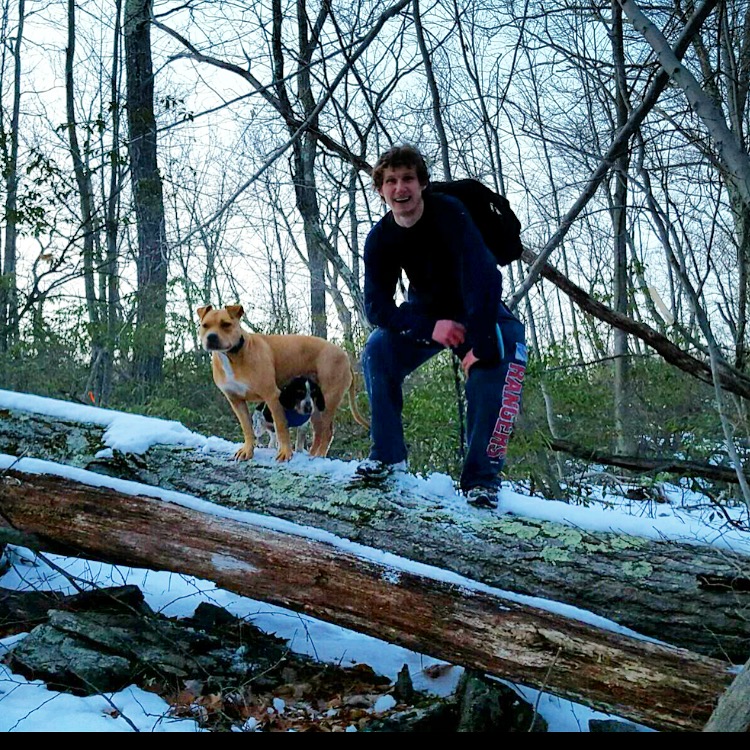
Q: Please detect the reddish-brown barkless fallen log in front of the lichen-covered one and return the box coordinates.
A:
[0,471,731,730]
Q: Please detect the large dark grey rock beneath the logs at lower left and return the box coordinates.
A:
[0,586,318,694]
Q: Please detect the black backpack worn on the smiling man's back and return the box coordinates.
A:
[429,179,523,266]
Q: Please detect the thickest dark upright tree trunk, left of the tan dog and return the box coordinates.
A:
[124,0,168,383]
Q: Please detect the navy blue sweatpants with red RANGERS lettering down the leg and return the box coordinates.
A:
[362,305,526,490]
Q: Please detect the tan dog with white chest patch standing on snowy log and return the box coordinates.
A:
[198,305,369,461]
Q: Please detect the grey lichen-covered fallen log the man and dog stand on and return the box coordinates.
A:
[0,406,750,663]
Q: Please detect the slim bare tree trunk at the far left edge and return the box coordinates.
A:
[0,0,26,352]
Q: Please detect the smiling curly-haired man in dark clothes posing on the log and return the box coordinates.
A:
[357,146,526,508]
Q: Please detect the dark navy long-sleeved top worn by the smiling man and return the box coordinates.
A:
[365,193,502,361]
